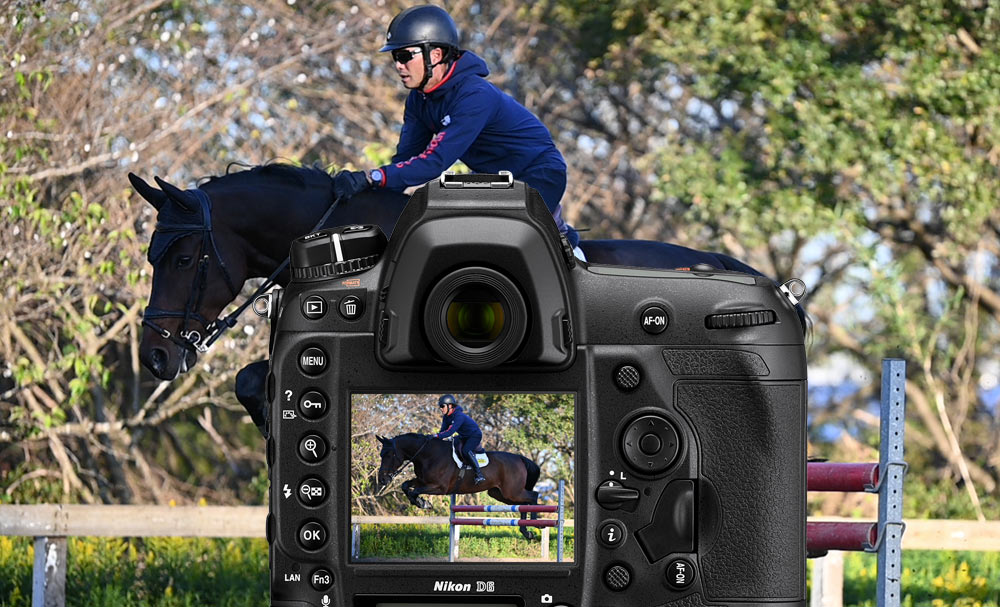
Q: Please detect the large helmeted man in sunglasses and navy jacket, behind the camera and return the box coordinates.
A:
[334,5,584,259]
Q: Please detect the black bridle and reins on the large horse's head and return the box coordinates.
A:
[142,188,340,353]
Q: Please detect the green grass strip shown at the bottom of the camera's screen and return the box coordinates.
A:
[359,525,573,562]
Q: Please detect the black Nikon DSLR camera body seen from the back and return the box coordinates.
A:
[267,174,806,607]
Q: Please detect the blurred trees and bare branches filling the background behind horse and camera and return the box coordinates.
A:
[0,0,1000,519]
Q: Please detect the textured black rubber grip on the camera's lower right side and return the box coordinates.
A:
[676,382,806,601]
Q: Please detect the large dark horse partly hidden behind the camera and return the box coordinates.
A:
[128,164,796,429]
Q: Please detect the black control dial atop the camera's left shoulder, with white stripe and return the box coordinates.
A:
[289,225,387,282]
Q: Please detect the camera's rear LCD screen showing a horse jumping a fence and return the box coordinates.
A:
[350,392,576,564]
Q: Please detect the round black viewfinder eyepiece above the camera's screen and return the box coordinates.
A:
[424,267,527,369]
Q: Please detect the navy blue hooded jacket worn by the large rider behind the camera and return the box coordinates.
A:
[382,51,579,245]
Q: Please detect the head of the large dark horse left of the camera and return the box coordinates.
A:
[128,173,247,380]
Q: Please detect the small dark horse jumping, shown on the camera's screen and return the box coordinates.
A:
[374,432,541,540]
